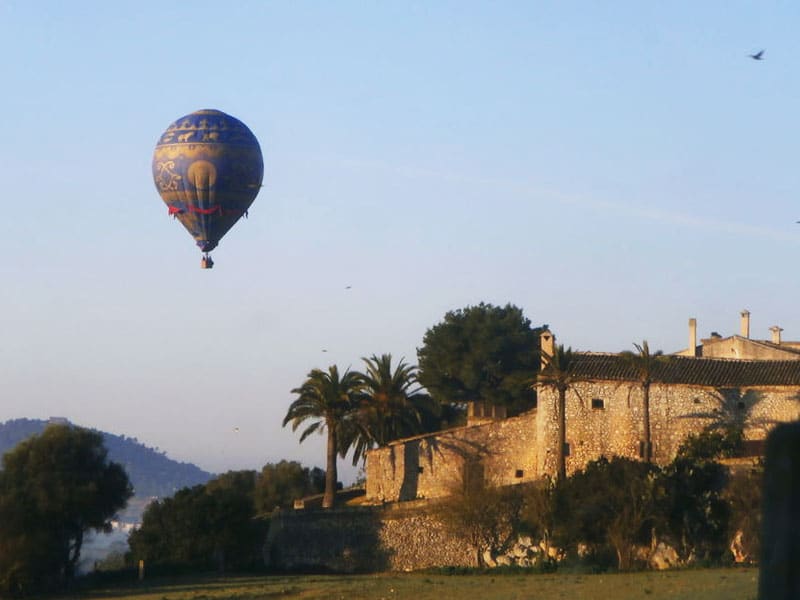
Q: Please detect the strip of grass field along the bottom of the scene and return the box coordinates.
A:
[65,569,758,600]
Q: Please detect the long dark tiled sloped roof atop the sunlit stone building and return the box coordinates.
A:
[575,352,800,387]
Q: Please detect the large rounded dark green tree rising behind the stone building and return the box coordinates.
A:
[417,303,541,414]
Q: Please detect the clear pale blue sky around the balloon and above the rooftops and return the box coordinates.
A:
[0,0,800,479]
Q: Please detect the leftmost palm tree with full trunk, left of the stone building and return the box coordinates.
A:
[283,365,362,508]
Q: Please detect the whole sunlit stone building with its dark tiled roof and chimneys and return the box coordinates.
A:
[366,311,800,503]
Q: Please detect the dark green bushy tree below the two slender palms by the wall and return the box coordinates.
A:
[556,457,661,571]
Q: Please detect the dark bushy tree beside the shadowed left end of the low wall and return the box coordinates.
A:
[128,471,265,571]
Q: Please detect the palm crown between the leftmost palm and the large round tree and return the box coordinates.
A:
[348,354,438,464]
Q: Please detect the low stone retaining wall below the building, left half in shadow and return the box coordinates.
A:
[264,502,477,573]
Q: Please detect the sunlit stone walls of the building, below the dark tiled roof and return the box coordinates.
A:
[366,381,800,496]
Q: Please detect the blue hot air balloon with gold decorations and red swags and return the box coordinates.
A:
[153,109,264,269]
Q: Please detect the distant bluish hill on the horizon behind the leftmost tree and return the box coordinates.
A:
[0,419,213,500]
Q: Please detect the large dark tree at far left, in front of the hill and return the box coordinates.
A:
[0,425,132,592]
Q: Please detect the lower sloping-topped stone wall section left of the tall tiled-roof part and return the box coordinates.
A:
[366,410,538,503]
